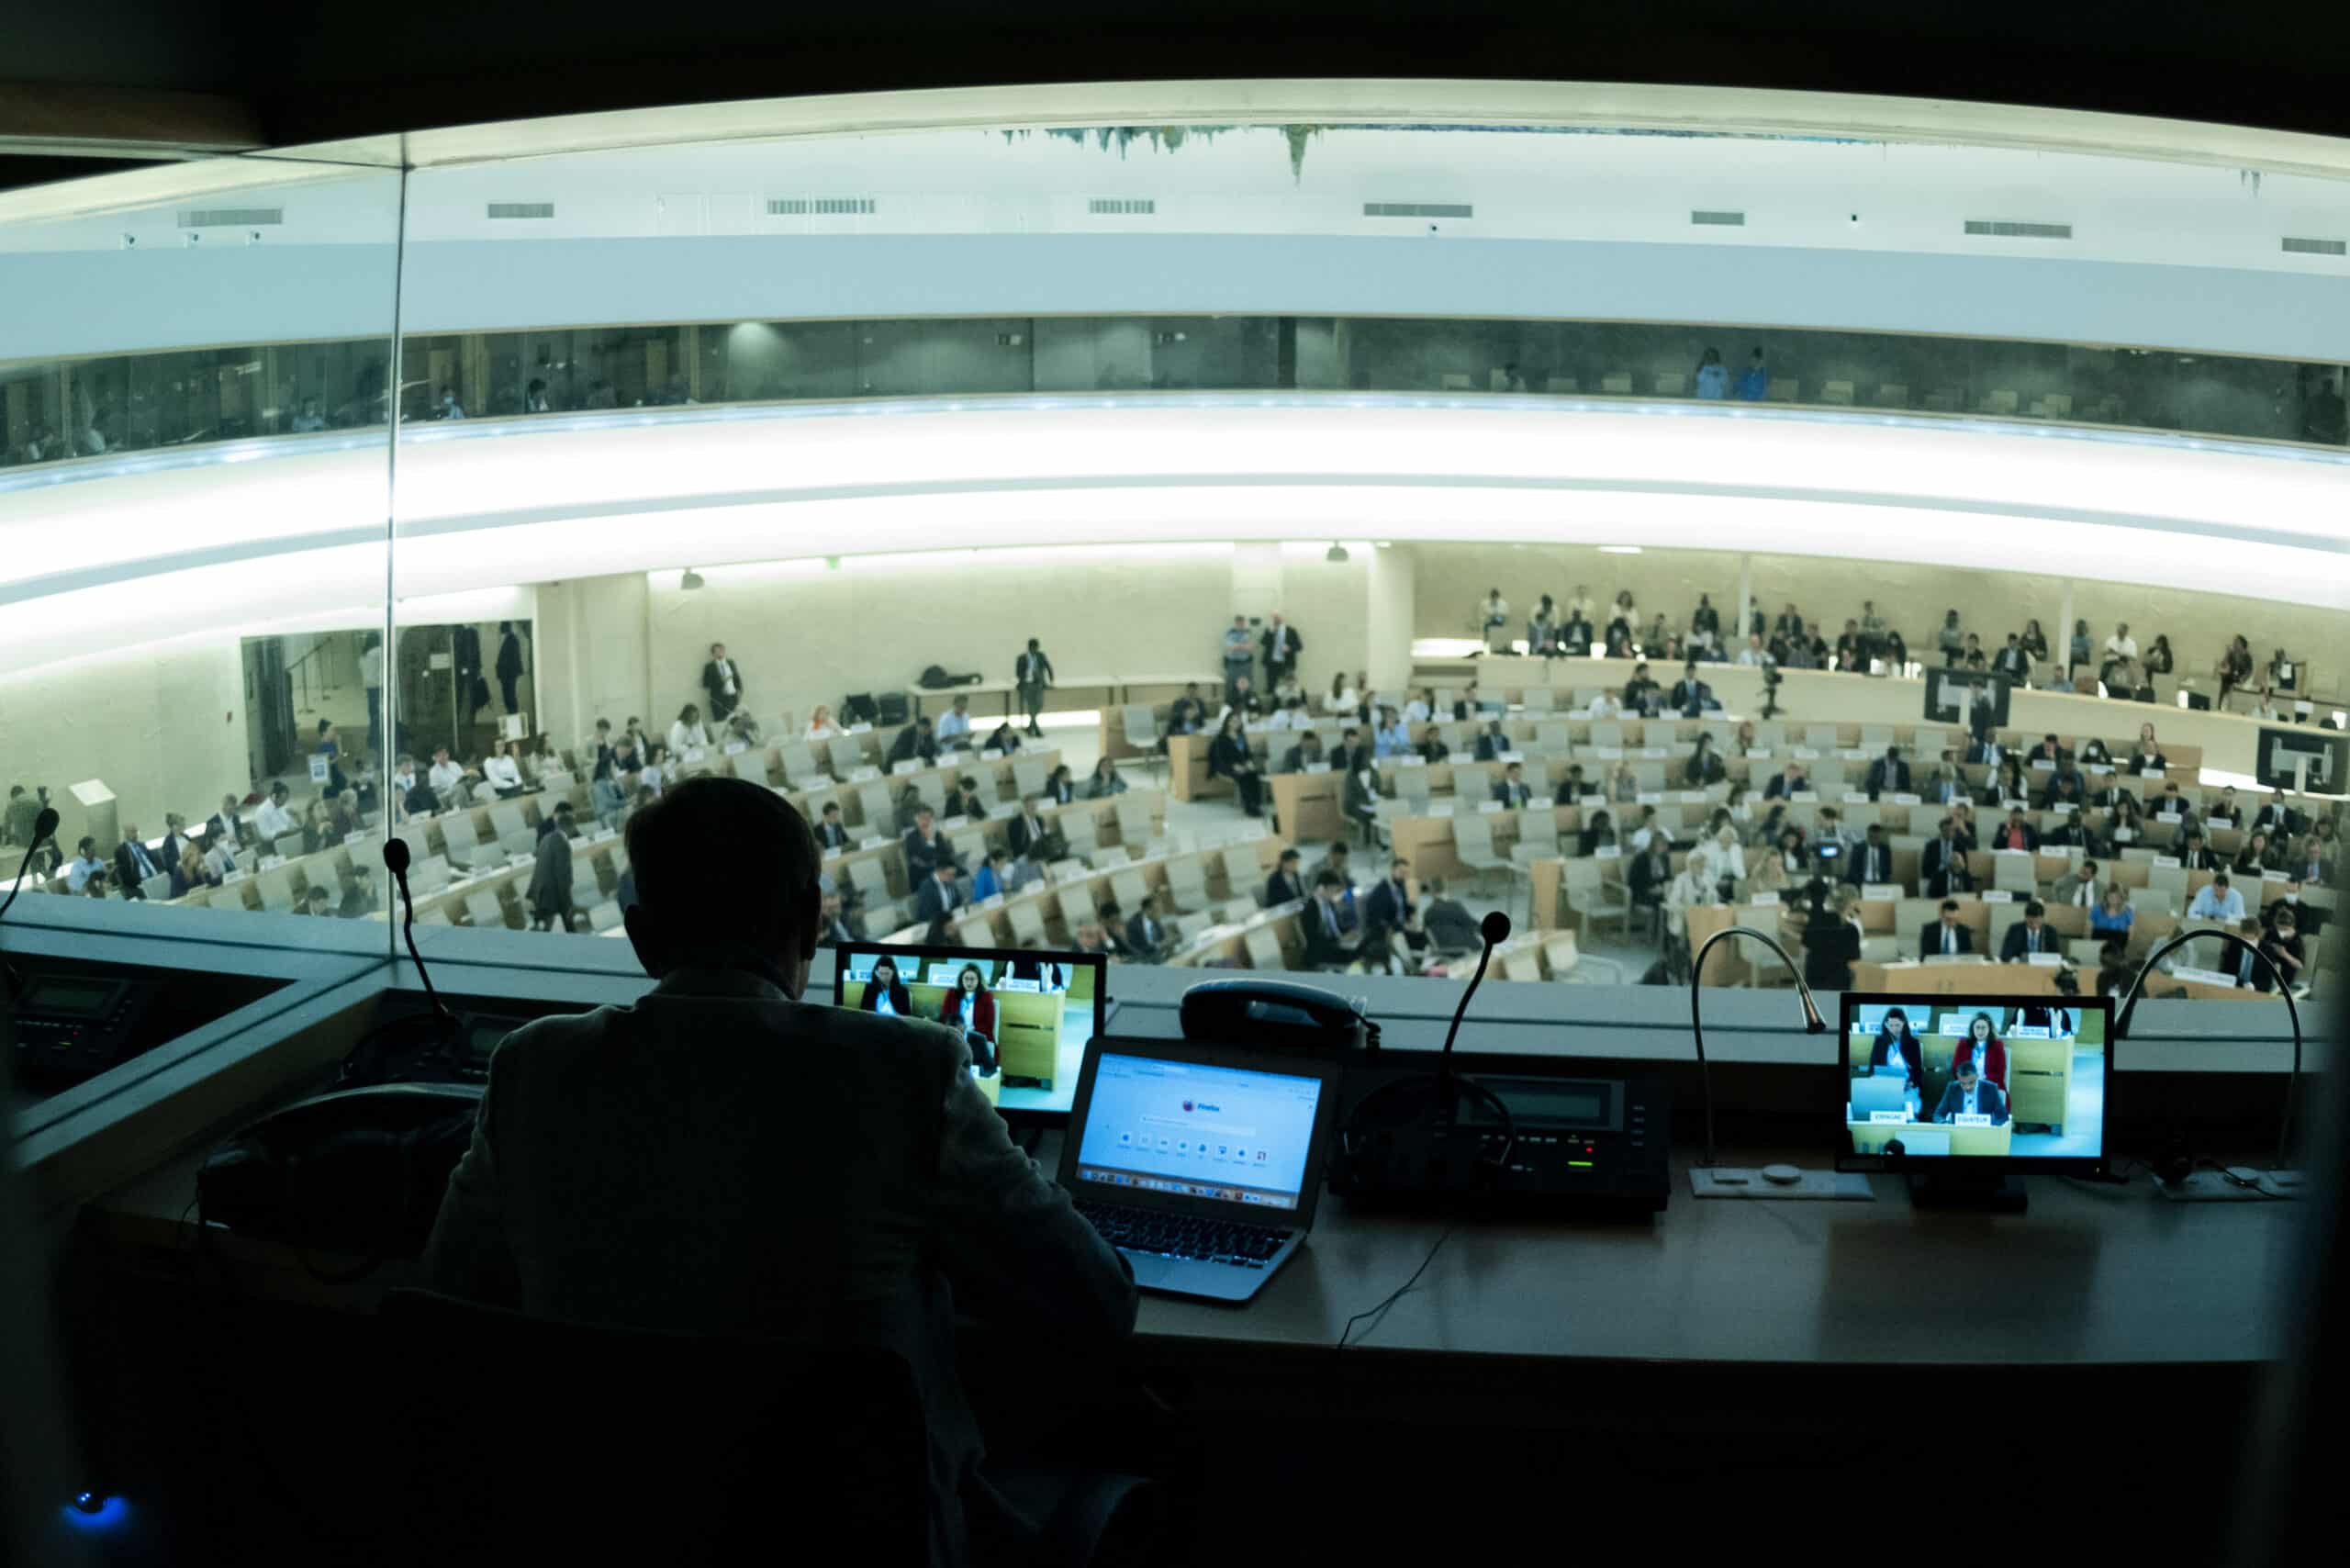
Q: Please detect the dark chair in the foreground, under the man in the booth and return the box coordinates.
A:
[378,1288,1166,1568]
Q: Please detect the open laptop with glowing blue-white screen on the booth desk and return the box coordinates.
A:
[1060,1036,1339,1303]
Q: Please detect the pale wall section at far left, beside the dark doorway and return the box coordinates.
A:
[0,637,252,858]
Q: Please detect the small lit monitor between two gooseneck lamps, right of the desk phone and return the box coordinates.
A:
[1835,992,2112,1175]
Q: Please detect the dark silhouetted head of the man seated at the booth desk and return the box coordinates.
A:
[622,776,822,997]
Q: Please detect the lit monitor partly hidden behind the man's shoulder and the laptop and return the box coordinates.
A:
[832,943,1109,1124]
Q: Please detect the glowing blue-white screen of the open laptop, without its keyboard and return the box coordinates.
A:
[1076,1051,1323,1208]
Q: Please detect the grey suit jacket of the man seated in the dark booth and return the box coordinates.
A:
[425,971,1137,1568]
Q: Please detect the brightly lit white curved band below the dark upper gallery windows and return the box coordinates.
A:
[0,395,2350,667]
